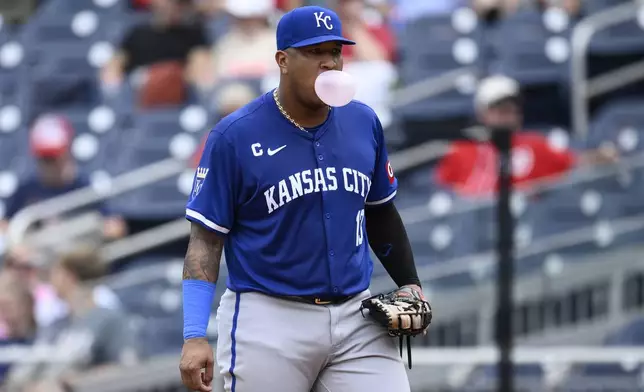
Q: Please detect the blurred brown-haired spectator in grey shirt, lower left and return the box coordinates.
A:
[4,248,137,385]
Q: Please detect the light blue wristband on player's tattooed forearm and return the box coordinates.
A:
[183,280,216,340]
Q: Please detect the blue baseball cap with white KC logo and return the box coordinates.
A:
[277,6,356,50]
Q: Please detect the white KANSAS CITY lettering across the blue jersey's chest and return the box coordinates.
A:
[264,167,371,214]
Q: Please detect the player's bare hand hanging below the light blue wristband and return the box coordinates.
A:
[179,338,215,392]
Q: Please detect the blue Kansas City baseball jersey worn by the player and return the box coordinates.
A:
[186,92,398,296]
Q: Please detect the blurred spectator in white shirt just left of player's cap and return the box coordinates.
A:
[204,0,279,87]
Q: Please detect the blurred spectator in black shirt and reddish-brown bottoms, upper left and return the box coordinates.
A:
[101,0,209,107]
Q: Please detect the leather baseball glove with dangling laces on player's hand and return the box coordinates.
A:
[360,286,432,369]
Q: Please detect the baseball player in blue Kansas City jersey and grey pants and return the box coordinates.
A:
[180,6,424,392]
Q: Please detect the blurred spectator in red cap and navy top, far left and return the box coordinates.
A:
[0,114,127,239]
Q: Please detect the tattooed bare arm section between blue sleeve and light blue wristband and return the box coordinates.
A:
[183,223,224,283]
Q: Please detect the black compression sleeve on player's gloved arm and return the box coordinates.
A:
[365,203,420,287]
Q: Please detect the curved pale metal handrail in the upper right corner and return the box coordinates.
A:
[570,0,644,137]
